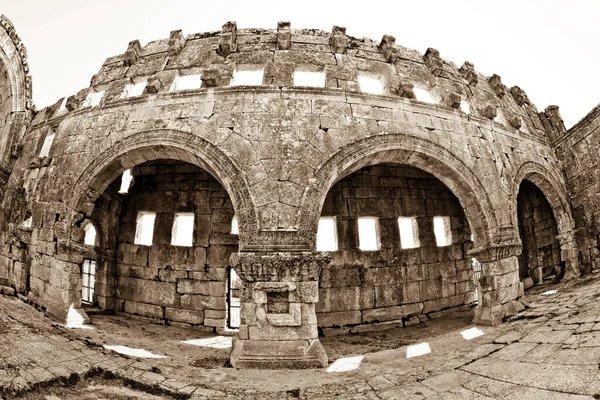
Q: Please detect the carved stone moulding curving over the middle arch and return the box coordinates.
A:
[301,134,498,248]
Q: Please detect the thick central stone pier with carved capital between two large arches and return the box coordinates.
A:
[230,252,331,369]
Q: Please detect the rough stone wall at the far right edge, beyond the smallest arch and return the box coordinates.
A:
[556,105,600,272]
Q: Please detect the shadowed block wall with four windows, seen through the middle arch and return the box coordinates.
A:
[317,165,475,328]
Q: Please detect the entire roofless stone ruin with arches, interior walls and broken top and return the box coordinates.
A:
[0,17,600,368]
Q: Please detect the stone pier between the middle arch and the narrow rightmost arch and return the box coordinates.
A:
[471,244,524,325]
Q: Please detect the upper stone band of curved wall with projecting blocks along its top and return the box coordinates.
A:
[29,21,556,142]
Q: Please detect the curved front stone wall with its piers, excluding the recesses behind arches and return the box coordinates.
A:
[2,23,578,366]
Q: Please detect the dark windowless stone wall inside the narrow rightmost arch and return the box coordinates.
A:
[517,180,562,283]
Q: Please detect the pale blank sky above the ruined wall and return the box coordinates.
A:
[0,0,600,128]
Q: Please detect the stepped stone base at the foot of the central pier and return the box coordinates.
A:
[230,338,327,369]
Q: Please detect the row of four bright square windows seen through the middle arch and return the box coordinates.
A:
[317,216,452,251]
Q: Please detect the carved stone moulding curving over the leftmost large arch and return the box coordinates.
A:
[68,129,258,239]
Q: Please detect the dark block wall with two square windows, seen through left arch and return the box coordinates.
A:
[115,160,238,328]
